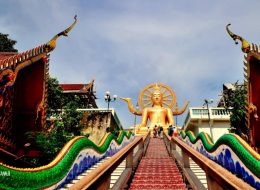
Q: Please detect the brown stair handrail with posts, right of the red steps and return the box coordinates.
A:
[163,132,253,190]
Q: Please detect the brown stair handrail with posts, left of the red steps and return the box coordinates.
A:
[69,134,150,190]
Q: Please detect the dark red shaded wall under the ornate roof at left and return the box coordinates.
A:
[13,59,45,148]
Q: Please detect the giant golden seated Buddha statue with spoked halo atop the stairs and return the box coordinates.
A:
[121,83,189,134]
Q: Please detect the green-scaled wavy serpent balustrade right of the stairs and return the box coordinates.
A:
[179,131,260,189]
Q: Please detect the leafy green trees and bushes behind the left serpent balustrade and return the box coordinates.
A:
[27,77,83,166]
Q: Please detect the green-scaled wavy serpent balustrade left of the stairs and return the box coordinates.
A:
[0,131,136,189]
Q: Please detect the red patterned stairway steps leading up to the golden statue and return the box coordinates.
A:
[130,138,187,190]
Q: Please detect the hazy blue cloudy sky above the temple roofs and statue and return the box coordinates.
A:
[0,0,260,128]
